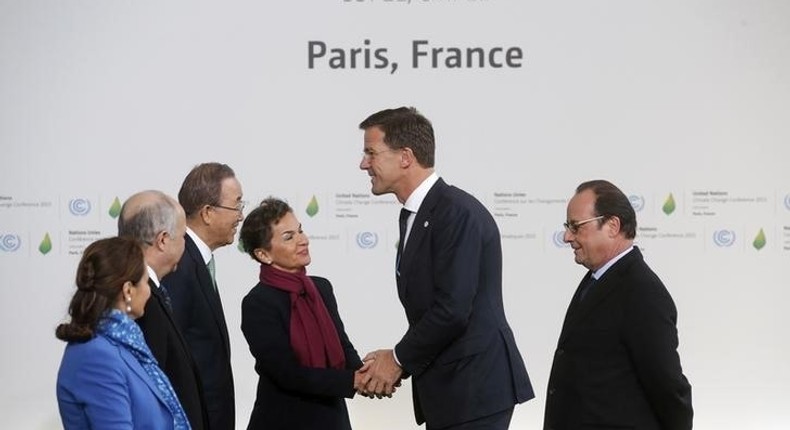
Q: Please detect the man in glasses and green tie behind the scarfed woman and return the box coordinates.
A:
[162,163,244,430]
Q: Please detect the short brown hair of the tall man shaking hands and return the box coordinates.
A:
[359,107,436,167]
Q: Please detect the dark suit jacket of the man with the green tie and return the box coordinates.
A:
[162,234,235,430]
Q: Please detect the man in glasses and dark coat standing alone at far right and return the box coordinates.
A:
[544,180,693,430]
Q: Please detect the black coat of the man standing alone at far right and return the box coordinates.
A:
[544,248,693,430]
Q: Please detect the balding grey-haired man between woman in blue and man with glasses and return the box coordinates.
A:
[118,190,208,430]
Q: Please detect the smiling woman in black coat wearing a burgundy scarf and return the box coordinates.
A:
[241,197,370,430]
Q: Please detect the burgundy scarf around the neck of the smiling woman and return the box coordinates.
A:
[260,264,346,369]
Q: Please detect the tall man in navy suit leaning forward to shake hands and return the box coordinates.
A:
[359,107,534,430]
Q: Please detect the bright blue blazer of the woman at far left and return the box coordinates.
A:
[57,335,173,430]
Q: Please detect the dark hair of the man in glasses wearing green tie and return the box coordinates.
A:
[178,163,236,218]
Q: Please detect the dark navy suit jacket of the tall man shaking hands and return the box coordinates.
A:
[395,179,534,427]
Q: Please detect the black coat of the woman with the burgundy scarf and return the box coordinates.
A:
[241,277,362,430]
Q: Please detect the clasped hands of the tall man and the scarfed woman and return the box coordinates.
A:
[354,349,403,399]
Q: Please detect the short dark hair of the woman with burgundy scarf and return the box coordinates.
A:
[239,197,293,261]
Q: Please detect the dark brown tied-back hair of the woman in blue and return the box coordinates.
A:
[55,237,146,342]
